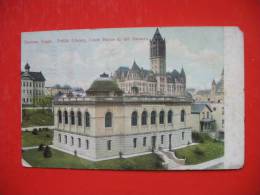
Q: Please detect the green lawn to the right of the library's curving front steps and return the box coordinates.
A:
[175,136,224,165]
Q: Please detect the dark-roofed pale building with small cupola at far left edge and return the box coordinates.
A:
[21,63,45,105]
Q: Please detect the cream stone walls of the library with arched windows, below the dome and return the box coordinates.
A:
[54,96,192,160]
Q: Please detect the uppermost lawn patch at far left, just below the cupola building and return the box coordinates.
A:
[22,109,54,127]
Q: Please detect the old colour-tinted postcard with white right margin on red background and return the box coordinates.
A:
[21,27,244,170]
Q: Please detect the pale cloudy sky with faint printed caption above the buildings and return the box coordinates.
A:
[21,27,224,89]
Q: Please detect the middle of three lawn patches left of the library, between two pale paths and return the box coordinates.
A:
[22,130,53,147]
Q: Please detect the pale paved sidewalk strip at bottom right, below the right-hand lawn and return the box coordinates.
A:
[174,157,224,170]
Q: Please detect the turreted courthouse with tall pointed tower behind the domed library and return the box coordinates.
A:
[113,28,186,96]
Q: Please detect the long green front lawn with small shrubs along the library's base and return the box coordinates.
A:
[23,149,163,170]
